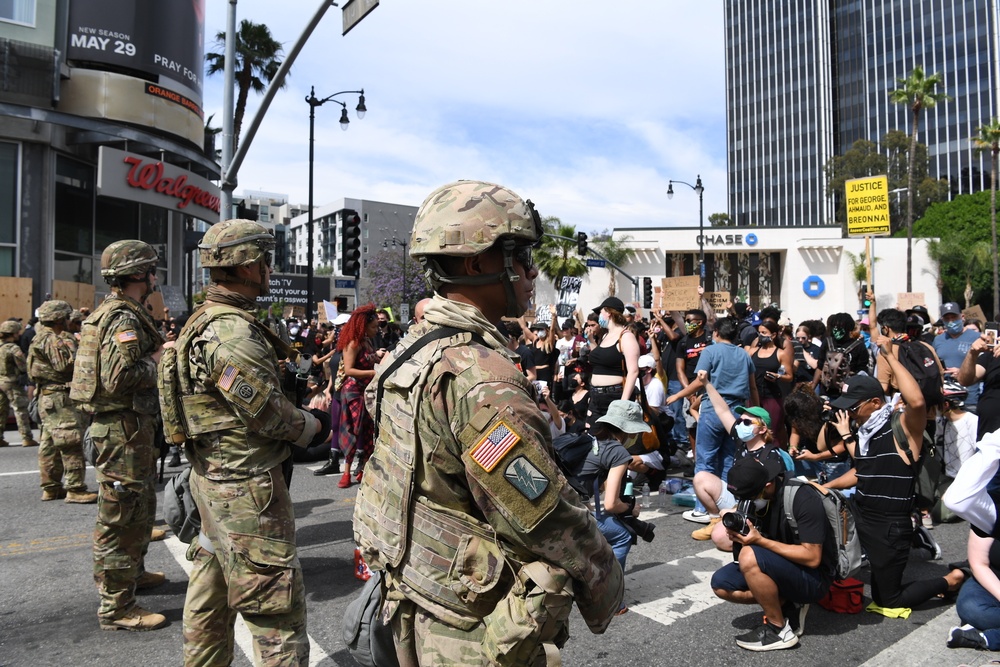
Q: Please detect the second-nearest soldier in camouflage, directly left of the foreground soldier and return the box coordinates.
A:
[169,220,329,667]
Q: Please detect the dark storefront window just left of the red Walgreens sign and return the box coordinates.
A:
[56,155,94,255]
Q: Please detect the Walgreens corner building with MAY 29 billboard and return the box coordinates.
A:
[0,0,219,319]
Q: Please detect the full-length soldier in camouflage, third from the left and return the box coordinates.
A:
[70,240,167,630]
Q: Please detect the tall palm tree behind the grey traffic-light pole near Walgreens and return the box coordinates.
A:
[205,19,287,153]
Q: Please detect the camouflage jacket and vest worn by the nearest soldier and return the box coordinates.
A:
[354,296,623,632]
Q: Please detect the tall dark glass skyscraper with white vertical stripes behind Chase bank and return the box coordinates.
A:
[725,0,1000,226]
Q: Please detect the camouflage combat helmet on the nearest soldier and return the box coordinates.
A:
[410,181,542,260]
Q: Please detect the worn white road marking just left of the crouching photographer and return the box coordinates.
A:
[629,548,733,625]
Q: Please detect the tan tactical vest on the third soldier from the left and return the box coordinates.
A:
[69,294,163,414]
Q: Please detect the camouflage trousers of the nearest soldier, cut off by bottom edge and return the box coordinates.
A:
[389,600,560,667]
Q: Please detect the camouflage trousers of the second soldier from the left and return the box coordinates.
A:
[38,390,87,493]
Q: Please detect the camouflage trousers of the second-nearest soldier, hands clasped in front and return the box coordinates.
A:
[184,466,309,667]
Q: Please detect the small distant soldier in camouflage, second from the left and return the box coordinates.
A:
[28,300,97,504]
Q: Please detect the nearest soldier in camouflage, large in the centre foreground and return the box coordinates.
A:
[354,181,624,667]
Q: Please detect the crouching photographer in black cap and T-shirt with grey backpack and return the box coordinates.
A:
[712,456,837,651]
